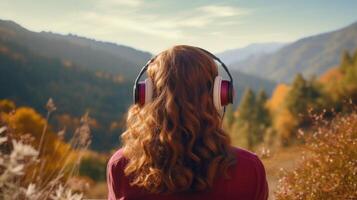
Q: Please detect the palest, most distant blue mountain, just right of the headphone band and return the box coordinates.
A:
[217,42,286,65]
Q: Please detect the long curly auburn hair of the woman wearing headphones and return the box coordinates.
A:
[122,45,235,193]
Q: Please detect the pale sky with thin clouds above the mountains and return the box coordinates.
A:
[0,0,357,54]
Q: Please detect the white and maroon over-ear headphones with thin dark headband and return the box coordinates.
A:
[133,47,234,115]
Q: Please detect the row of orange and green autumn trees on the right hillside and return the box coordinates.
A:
[224,50,357,149]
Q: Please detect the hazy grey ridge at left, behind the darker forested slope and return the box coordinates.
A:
[0,20,151,79]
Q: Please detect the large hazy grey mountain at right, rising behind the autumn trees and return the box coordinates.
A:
[231,22,357,82]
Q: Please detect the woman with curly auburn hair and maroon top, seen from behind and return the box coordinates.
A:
[107,45,268,200]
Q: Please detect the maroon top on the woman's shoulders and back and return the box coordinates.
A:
[107,147,268,200]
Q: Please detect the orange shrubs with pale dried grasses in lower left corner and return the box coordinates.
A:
[0,99,91,200]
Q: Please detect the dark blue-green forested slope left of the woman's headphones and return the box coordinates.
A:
[0,39,132,150]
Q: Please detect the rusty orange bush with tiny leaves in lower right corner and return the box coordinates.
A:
[276,112,357,200]
